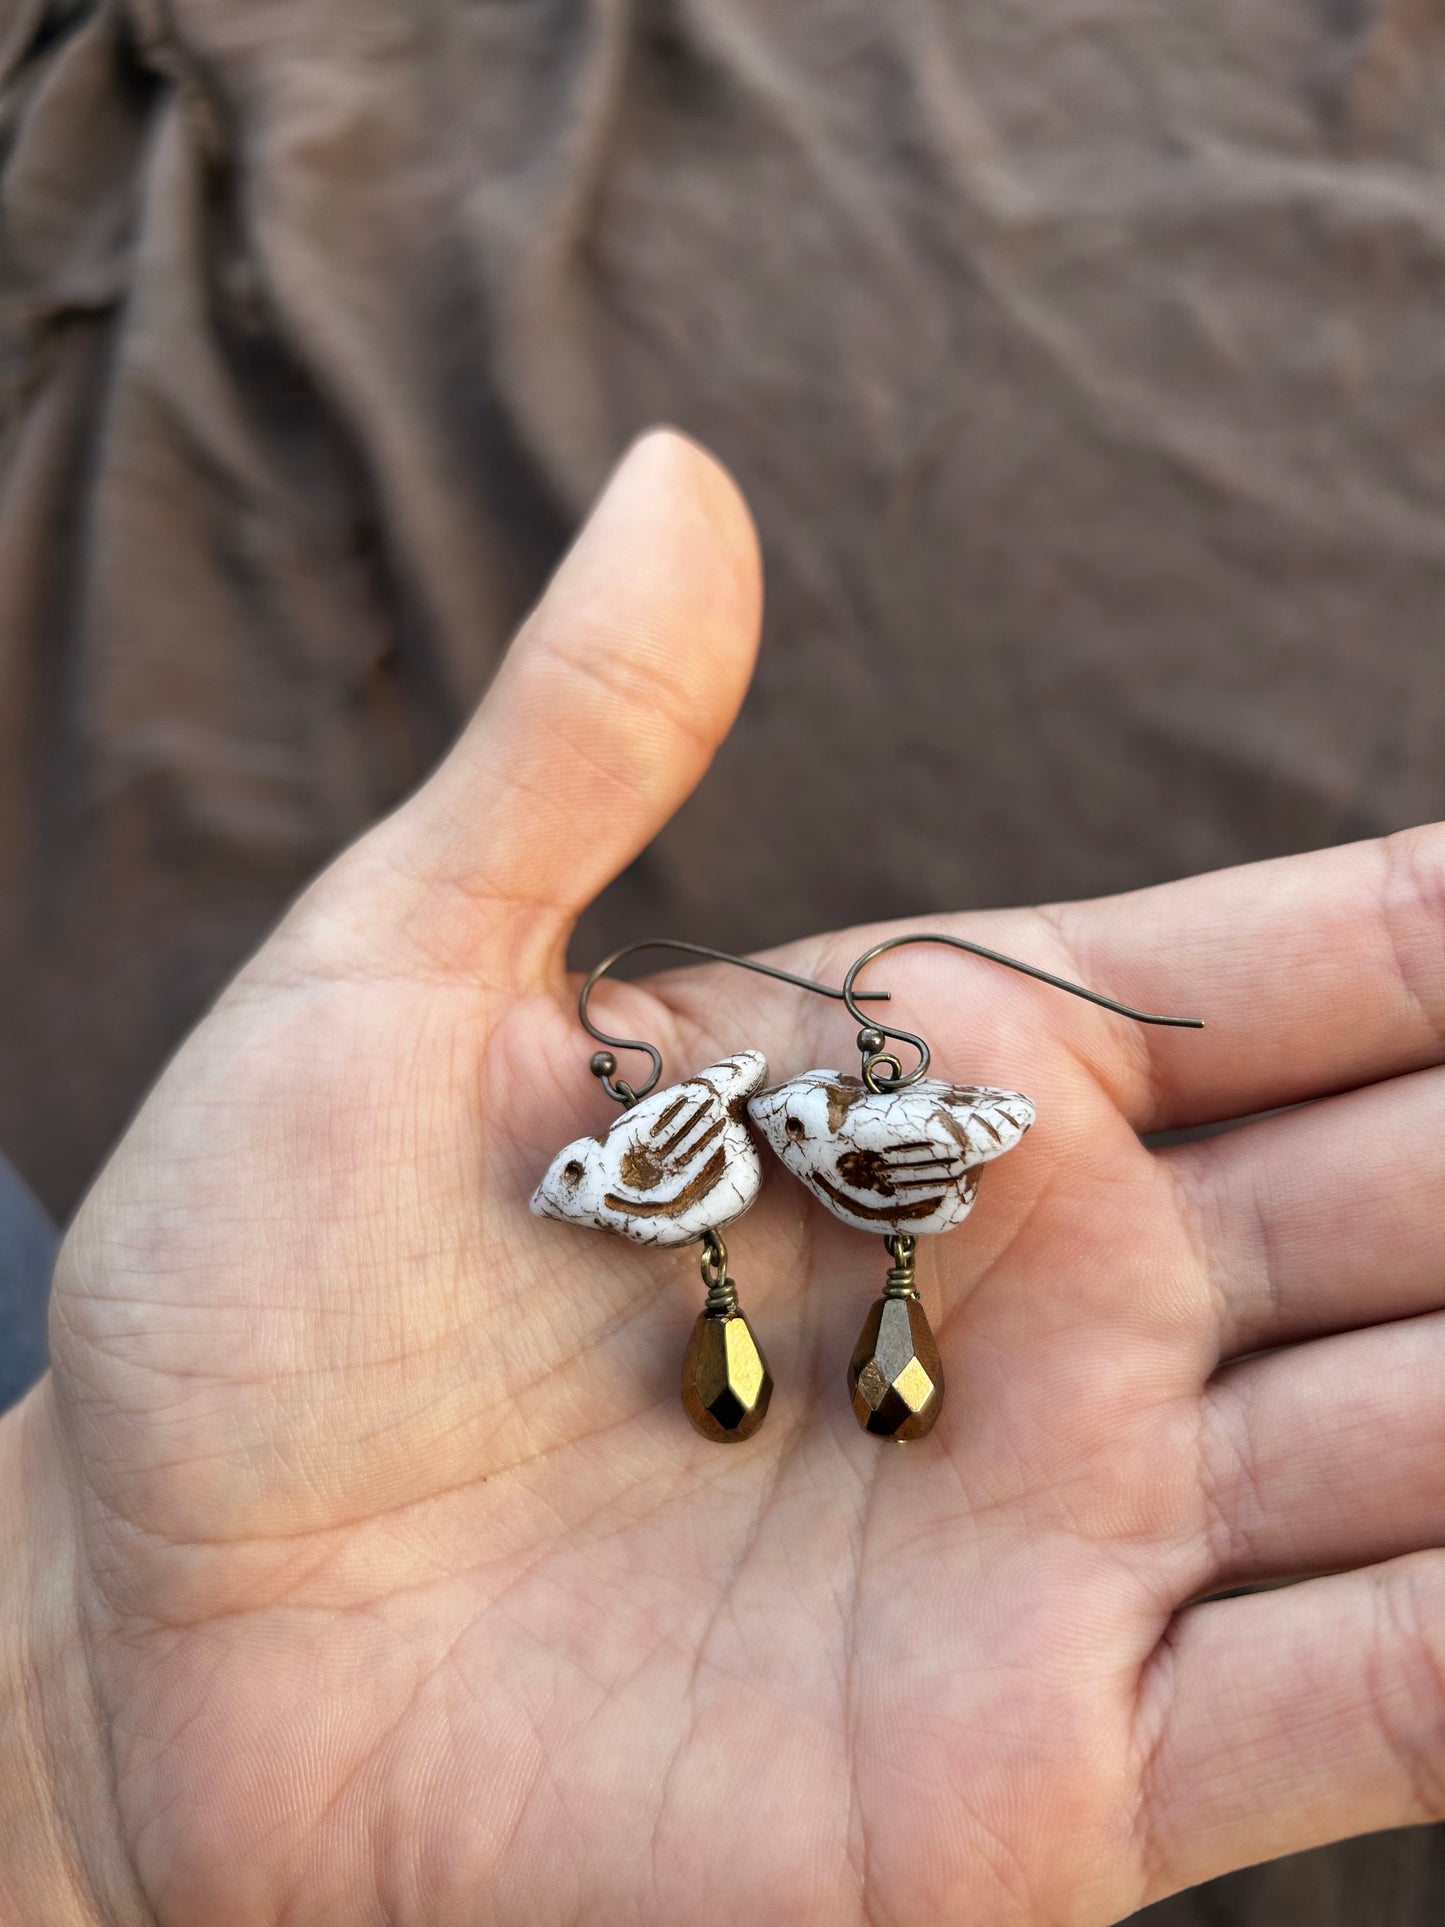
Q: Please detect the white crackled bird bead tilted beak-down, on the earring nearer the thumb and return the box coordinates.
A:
[532,1050,767,1245]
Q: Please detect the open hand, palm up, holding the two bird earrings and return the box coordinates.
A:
[8,436,1445,1927]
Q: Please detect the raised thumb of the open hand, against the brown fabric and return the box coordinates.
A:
[368,430,761,981]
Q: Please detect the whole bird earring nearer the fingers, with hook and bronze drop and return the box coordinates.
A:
[748,933,1202,1439]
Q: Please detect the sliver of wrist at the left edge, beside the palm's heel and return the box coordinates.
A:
[0,1380,148,1927]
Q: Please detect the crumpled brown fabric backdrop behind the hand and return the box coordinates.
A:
[0,0,1445,1903]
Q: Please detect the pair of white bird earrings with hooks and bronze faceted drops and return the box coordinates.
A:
[532,931,1202,1443]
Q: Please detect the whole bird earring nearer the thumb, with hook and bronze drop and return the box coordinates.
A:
[532,937,886,1443]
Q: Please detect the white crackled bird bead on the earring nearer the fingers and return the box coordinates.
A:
[748,1071,1035,1235]
